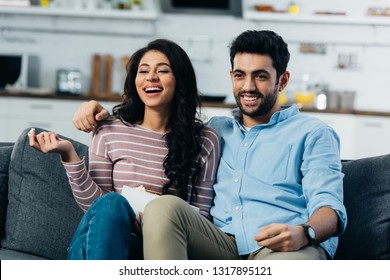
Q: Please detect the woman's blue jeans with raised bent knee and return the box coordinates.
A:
[68,193,143,260]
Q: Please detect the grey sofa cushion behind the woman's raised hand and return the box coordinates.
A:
[1,129,88,259]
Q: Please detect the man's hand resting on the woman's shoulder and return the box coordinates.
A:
[73,100,110,132]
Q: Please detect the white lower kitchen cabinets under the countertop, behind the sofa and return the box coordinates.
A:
[0,94,390,159]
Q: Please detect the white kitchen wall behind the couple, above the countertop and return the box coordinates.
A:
[0,0,390,111]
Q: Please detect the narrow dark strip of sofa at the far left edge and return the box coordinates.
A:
[0,143,13,241]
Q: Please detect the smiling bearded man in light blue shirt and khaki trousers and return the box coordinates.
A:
[75,31,347,259]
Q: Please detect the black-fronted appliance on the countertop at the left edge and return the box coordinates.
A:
[0,53,39,90]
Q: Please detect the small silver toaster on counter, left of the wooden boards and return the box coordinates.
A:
[57,68,82,95]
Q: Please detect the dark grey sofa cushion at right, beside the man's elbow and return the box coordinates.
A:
[336,155,390,260]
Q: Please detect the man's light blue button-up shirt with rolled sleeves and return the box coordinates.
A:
[208,105,347,257]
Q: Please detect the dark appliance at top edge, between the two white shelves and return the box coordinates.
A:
[160,0,242,16]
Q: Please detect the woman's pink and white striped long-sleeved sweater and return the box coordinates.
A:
[63,118,221,219]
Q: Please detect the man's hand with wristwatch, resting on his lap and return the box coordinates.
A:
[255,224,308,252]
